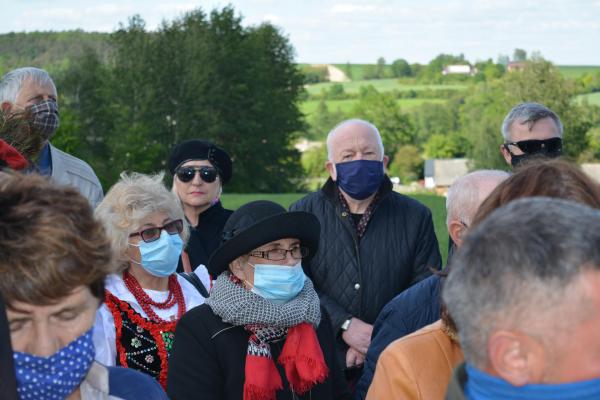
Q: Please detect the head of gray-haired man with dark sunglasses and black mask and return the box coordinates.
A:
[500,103,563,167]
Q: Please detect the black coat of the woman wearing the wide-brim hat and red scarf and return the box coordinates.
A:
[167,304,351,400]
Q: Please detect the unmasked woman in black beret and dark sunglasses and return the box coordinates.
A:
[168,139,237,278]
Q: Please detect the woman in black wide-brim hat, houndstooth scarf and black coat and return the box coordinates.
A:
[167,201,350,400]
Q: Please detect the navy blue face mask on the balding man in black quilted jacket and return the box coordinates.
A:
[335,160,383,200]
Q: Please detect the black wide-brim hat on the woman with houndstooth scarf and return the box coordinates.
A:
[207,200,321,278]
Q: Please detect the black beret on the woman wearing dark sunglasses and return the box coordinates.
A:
[169,139,232,183]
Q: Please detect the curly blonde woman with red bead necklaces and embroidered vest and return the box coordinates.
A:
[94,174,204,387]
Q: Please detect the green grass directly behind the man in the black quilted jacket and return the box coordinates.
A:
[221,193,448,265]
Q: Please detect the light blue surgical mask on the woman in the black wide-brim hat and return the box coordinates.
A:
[250,262,306,304]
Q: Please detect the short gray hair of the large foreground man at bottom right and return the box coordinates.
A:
[443,197,600,368]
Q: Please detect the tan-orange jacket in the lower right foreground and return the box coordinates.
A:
[367,320,464,400]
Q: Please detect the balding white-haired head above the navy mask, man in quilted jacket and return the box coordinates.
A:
[327,119,383,163]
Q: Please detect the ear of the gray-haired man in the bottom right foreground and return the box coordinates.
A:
[488,331,545,386]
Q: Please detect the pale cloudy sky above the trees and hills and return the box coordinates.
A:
[0,0,600,65]
